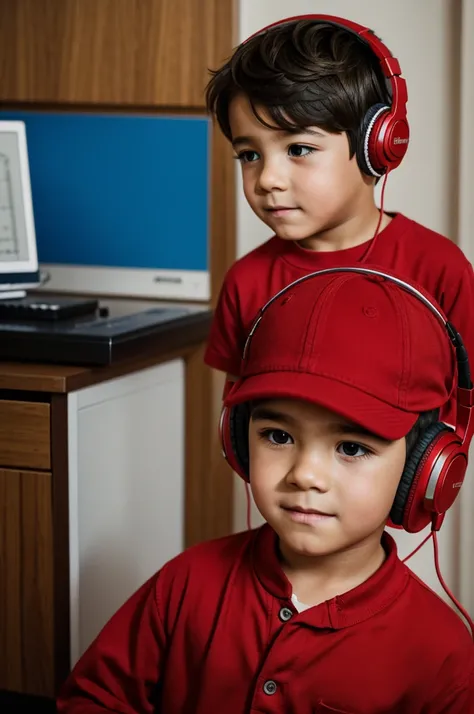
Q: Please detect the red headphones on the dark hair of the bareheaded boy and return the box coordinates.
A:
[244,15,410,177]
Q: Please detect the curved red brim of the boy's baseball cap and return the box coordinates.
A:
[225,372,419,441]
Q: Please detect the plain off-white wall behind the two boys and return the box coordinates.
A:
[235,0,464,608]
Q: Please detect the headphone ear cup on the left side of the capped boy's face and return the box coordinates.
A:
[221,404,250,481]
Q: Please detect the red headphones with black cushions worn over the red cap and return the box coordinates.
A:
[220,267,474,533]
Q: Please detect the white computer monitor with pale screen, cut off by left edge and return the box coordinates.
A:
[0,121,40,299]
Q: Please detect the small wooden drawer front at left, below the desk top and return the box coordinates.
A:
[0,400,51,470]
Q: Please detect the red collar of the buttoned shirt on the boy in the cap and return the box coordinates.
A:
[252,524,409,630]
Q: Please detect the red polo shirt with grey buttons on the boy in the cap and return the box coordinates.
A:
[58,525,474,714]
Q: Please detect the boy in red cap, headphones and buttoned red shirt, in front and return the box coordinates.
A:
[58,268,474,714]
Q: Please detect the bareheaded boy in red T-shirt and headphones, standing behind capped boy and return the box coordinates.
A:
[205,16,474,421]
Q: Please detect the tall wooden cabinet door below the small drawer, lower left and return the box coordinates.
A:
[0,469,54,696]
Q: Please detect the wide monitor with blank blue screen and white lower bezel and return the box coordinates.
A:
[0,110,211,302]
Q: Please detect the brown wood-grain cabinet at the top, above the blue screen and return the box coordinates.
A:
[0,0,233,109]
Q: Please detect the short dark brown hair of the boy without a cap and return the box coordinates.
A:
[206,20,390,156]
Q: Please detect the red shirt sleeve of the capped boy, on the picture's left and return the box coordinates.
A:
[57,575,166,714]
